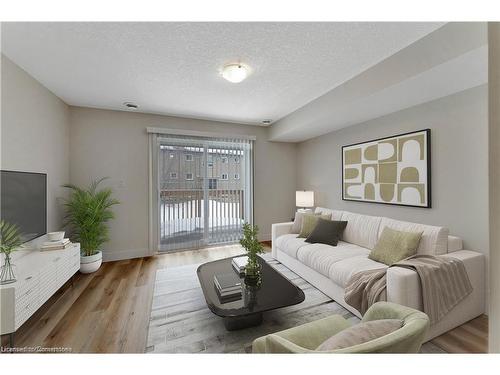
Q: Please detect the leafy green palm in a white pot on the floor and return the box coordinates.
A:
[64,178,120,273]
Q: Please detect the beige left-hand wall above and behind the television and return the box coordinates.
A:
[1,55,69,231]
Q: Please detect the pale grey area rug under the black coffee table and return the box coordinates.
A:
[146,254,442,353]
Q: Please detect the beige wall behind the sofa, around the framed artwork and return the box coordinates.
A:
[297,85,489,254]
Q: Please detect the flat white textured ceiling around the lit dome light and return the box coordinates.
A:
[2,22,443,124]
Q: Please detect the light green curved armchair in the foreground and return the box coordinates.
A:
[252,302,429,353]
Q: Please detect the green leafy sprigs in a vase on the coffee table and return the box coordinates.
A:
[240,223,264,286]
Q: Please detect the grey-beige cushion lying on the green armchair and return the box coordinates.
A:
[316,319,403,351]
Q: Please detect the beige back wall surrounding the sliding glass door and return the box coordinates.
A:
[70,107,296,260]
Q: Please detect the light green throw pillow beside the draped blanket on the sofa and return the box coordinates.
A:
[368,227,423,266]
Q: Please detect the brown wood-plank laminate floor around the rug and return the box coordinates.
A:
[2,246,488,353]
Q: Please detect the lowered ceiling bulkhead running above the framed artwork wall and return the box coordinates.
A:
[269,22,488,142]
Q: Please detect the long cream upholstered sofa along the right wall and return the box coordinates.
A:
[272,207,485,340]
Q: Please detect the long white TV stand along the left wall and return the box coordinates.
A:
[0,243,80,346]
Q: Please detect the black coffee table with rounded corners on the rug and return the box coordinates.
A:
[197,257,305,331]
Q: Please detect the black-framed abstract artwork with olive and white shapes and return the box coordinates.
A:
[342,129,431,208]
